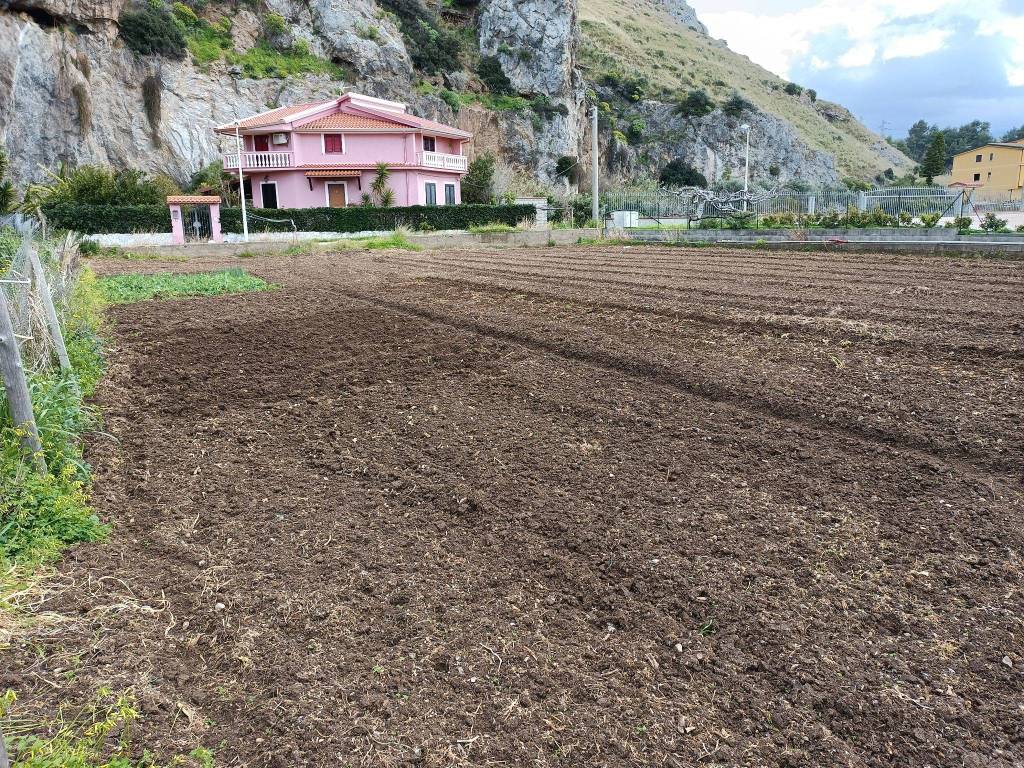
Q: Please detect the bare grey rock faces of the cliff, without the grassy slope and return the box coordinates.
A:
[0,0,902,193]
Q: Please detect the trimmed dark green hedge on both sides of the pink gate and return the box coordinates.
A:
[44,204,537,234]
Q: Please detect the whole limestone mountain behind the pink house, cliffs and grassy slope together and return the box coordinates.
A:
[0,0,909,193]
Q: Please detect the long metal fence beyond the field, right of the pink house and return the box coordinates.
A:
[605,186,1007,219]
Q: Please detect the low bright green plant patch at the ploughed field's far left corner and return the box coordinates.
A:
[99,269,272,304]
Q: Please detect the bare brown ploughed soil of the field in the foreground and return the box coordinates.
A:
[0,246,1024,768]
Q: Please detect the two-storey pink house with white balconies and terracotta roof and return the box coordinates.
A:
[215,93,471,208]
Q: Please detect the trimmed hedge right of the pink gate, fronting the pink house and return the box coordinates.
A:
[220,202,537,232]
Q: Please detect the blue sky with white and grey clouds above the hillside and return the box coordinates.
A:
[689,0,1024,137]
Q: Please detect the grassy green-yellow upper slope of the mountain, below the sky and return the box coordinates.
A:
[580,0,909,179]
